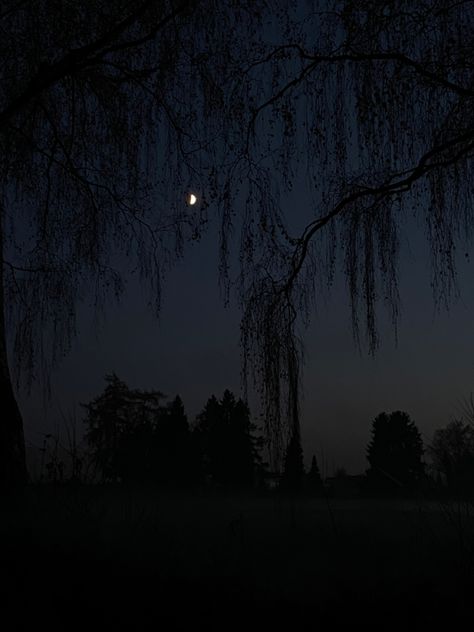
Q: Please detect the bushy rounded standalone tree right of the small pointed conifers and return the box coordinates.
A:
[367,410,424,492]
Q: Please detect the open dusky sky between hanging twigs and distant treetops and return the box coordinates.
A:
[22,207,474,475]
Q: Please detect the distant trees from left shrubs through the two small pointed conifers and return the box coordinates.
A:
[35,374,323,493]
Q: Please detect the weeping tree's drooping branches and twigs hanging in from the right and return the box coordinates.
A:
[235,0,474,470]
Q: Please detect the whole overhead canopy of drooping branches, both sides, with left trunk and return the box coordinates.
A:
[0,0,474,484]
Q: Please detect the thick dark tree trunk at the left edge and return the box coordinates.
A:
[0,217,27,490]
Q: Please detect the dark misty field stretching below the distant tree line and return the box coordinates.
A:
[0,488,474,631]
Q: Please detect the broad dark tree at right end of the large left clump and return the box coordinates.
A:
[194,390,264,488]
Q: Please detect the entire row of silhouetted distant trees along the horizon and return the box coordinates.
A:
[34,374,474,496]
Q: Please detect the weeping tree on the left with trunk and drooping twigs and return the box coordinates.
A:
[0,0,248,485]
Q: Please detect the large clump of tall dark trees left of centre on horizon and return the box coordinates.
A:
[83,374,266,489]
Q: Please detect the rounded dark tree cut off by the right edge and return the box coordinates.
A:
[428,420,474,494]
